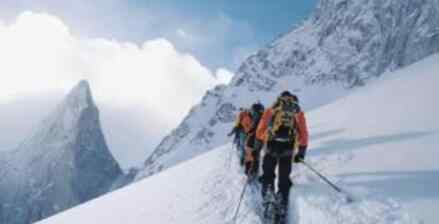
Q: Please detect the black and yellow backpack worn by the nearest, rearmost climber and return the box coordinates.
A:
[269,97,300,142]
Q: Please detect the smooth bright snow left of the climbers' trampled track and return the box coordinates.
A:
[38,146,258,224]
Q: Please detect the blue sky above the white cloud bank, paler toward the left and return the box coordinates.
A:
[0,0,317,70]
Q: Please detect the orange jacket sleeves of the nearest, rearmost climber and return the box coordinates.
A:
[256,108,308,146]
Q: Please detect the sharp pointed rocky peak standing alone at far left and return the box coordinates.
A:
[0,81,122,224]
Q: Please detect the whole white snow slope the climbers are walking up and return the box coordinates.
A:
[40,54,439,224]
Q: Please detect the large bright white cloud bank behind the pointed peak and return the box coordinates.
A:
[0,12,232,128]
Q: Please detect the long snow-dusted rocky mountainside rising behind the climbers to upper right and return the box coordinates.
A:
[137,0,439,179]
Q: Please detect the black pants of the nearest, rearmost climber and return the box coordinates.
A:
[261,141,294,202]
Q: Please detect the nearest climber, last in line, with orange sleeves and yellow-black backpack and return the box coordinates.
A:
[256,91,308,212]
